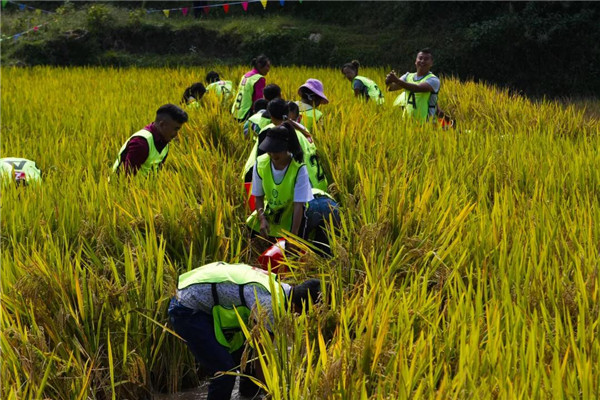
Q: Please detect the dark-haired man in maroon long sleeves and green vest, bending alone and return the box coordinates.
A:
[112,104,188,176]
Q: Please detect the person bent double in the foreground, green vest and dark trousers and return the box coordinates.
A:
[169,262,321,400]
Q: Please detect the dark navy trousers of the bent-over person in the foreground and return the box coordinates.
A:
[169,298,258,400]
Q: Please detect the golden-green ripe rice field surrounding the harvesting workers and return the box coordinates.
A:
[0,65,600,400]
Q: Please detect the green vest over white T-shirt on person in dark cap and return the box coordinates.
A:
[246,154,304,237]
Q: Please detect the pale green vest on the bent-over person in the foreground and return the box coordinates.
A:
[177,262,285,353]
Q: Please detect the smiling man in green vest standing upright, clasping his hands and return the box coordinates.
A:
[385,49,440,122]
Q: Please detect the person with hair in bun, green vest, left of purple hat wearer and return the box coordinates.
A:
[231,54,271,122]
